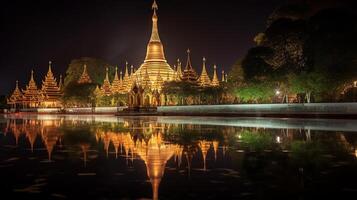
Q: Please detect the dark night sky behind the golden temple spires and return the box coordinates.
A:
[0,0,285,94]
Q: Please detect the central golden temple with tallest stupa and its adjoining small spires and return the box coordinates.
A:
[95,1,225,107]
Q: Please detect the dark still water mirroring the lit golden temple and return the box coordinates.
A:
[0,115,357,199]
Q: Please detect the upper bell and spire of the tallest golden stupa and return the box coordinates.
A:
[136,1,174,87]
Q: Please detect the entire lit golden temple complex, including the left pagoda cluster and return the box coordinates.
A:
[8,1,227,108]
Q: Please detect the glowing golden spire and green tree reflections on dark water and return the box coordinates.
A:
[4,116,357,199]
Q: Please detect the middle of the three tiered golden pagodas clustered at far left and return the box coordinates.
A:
[22,70,42,108]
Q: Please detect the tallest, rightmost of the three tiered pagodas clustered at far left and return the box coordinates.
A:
[41,61,62,107]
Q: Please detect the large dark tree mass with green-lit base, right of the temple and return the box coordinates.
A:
[229,4,357,102]
